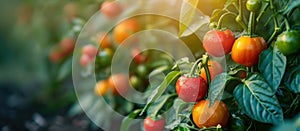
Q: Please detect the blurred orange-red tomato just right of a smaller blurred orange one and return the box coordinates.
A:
[108,74,130,95]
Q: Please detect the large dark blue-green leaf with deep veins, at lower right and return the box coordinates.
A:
[233,74,283,123]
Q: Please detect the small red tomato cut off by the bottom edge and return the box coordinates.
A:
[144,117,166,131]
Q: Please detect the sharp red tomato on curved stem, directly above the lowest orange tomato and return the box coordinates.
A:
[176,75,207,102]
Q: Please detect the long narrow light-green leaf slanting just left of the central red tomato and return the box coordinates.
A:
[141,71,181,114]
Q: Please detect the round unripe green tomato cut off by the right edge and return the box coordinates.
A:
[275,30,300,56]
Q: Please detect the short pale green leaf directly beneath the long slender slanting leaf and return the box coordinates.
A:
[147,94,174,116]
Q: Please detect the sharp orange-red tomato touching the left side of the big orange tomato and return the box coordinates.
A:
[203,29,235,57]
